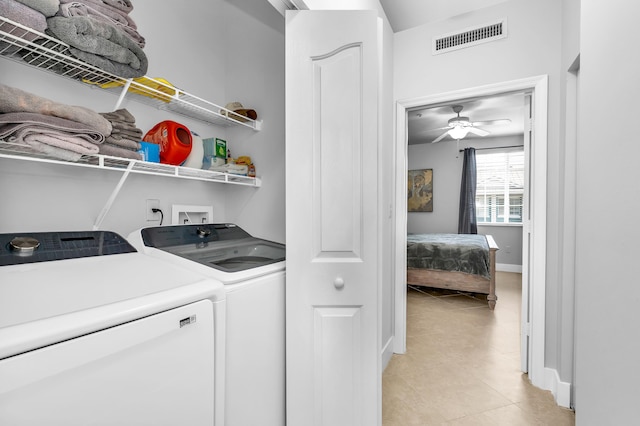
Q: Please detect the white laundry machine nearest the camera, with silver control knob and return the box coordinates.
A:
[0,231,225,426]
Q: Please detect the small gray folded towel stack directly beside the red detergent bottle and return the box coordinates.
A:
[99,108,142,160]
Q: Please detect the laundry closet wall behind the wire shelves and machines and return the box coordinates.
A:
[0,0,284,241]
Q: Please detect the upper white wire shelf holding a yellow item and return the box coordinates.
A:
[0,16,262,130]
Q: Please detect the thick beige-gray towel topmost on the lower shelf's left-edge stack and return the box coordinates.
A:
[0,84,112,137]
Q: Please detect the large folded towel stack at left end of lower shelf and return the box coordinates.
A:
[0,84,112,161]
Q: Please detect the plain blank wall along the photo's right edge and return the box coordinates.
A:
[575,0,640,426]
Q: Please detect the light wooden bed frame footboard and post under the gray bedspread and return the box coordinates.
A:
[407,235,498,310]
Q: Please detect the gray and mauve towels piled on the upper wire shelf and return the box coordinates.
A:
[0,0,149,78]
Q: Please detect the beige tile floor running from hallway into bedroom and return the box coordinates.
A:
[382,272,575,426]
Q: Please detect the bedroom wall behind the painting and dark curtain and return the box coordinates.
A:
[407,135,524,266]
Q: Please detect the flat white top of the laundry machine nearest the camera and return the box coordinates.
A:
[0,231,225,358]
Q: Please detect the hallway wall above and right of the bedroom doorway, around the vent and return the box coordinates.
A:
[394,0,572,381]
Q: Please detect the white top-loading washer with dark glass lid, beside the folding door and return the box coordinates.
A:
[128,223,286,426]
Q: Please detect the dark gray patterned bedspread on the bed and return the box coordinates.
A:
[407,234,490,279]
